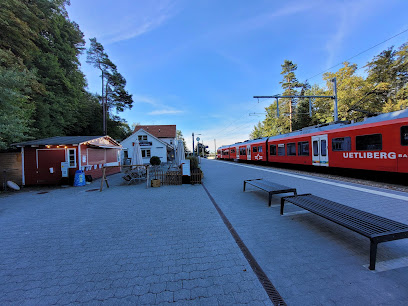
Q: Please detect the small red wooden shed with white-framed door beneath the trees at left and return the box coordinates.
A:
[14,136,122,185]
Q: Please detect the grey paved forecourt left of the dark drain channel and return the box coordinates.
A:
[0,175,271,305]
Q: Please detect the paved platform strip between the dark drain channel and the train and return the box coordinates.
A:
[201,160,408,305]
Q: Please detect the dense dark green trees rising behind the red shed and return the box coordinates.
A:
[0,0,131,148]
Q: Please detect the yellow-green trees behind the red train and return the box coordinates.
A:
[250,43,408,139]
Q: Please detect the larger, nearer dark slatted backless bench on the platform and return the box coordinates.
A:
[280,194,408,270]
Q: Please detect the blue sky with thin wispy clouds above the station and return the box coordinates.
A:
[68,0,408,151]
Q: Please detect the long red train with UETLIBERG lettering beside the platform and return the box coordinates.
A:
[217,109,408,173]
